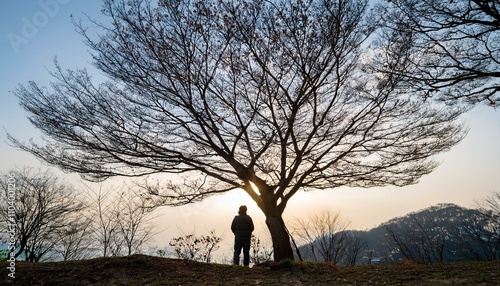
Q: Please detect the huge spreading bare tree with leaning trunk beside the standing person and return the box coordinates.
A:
[9,0,464,261]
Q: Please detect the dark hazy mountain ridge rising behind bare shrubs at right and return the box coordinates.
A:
[299,204,500,265]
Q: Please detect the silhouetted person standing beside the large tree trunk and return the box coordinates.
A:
[231,206,254,266]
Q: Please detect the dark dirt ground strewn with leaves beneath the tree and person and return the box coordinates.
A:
[0,255,500,285]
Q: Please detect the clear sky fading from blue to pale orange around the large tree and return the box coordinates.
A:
[0,0,500,255]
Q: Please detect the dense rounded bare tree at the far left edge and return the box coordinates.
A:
[0,167,84,262]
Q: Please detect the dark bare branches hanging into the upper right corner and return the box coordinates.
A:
[382,0,500,107]
